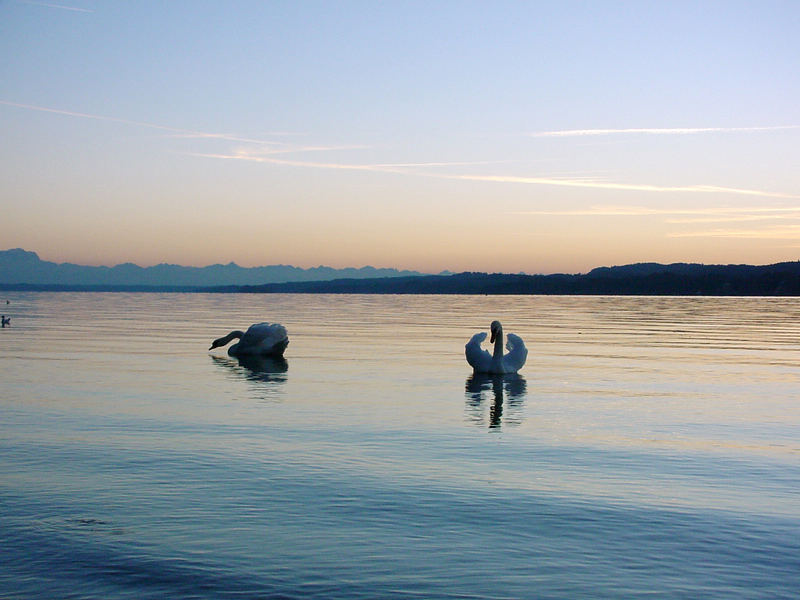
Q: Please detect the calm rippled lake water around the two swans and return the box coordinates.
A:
[0,293,800,600]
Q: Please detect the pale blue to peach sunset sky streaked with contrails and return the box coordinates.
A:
[0,0,800,273]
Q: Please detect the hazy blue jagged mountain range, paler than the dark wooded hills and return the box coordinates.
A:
[0,248,419,288]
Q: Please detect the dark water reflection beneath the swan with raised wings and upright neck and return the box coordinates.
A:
[464,373,527,429]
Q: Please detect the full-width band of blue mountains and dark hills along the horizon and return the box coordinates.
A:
[0,249,800,296]
